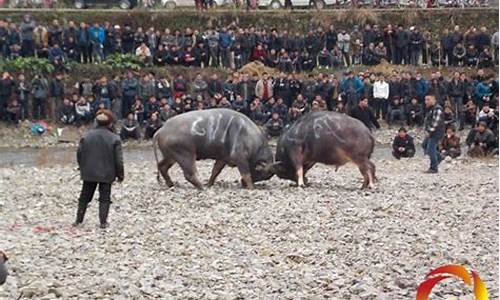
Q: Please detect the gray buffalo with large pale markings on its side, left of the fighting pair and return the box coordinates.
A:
[153,109,274,189]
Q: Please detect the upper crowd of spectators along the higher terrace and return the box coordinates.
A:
[0,15,498,72]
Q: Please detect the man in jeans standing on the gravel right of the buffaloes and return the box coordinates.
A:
[422,95,444,174]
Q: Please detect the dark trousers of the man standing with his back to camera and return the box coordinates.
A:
[76,181,111,224]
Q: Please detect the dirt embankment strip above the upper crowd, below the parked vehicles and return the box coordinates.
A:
[0,7,498,34]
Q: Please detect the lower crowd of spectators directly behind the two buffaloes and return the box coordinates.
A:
[0,69,498,155]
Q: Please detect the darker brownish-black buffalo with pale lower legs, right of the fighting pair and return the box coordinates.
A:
[272,111,376,188]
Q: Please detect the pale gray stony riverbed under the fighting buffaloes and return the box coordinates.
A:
[0,156,499,300]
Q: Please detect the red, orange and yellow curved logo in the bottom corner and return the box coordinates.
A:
[417,265,488,300]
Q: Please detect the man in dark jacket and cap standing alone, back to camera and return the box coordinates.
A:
[73,110,124,229]
